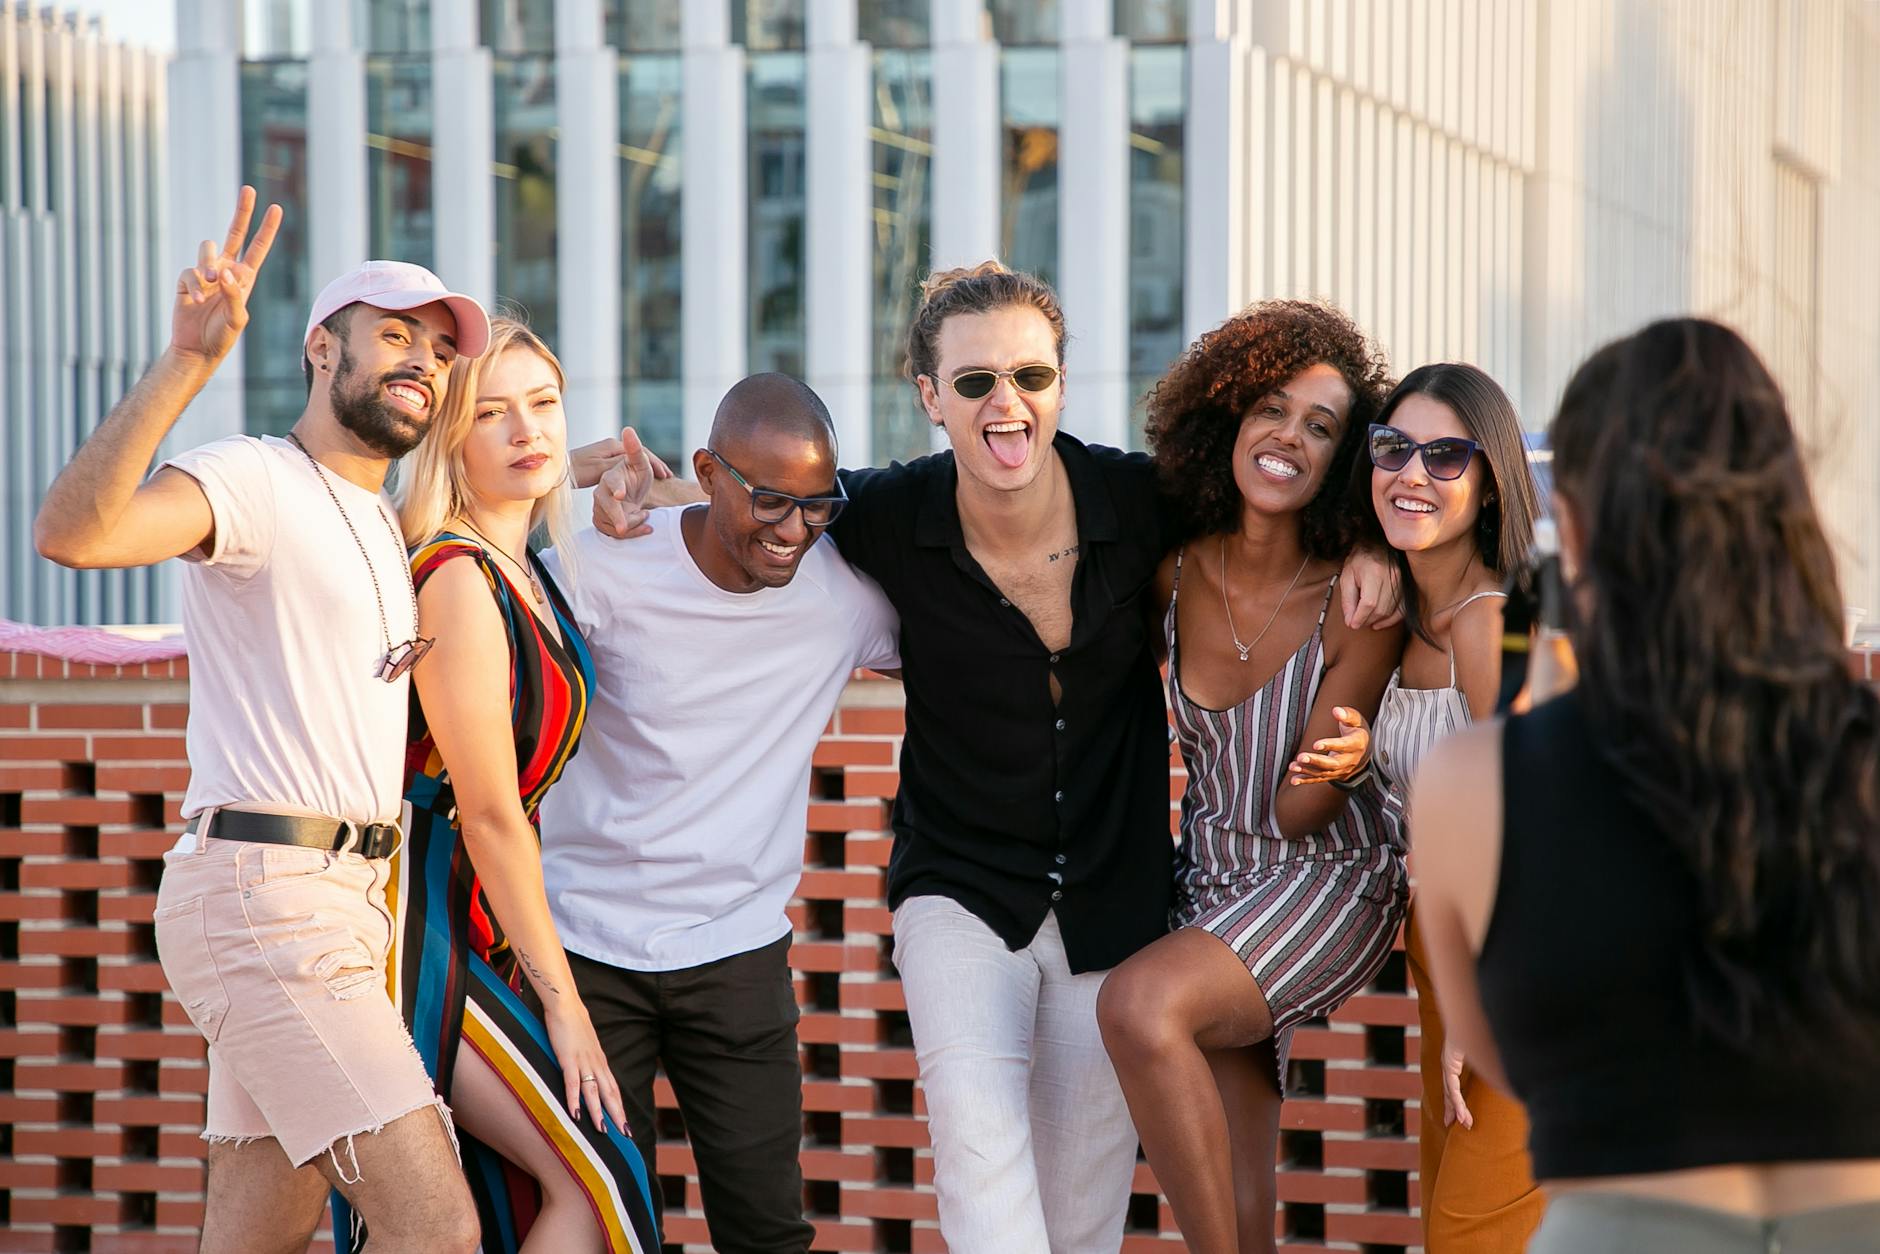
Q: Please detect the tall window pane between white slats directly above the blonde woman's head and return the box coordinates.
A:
[493,55,558,348]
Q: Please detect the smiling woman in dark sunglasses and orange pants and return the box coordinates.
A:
[1290,361,1545,1254]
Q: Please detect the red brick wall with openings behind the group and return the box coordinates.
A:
[0,654,1418,1254]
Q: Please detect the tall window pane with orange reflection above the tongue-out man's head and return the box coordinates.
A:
[998,47,1058,284]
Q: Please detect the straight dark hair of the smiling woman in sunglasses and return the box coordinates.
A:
[1352,361,1540,645]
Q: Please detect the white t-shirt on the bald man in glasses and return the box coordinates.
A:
[541,508,901,970]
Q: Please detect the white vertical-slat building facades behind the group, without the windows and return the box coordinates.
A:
[11,0,1880,622]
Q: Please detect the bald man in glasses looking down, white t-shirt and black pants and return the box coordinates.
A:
[541,374,901,1254]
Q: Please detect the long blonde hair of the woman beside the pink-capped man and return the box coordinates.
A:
[399,316,575,583]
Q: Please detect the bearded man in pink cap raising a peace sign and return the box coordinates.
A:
[34,188,489,1254]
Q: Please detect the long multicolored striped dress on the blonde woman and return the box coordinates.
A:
[333,532,660,1254]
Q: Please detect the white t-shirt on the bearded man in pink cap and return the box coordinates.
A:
[164,436,417,823]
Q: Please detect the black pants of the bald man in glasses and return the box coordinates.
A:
[568,936,816,1254]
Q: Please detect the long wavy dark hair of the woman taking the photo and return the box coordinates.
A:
[1553,318,1880,1066]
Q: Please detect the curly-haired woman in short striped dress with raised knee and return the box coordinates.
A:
[1098,301,1406,1252]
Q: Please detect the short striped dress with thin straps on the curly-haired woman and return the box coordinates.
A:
[1162,553,1408,1090]
